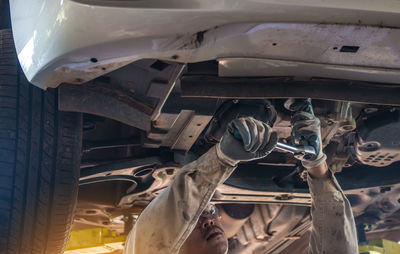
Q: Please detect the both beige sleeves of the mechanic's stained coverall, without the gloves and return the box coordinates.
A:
[124,147,358,254]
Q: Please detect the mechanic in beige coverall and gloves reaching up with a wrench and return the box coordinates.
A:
[124,112,358,254]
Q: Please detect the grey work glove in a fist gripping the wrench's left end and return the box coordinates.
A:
[217,117,278,166]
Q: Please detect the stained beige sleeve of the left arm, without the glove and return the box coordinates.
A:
[125,147,234,254]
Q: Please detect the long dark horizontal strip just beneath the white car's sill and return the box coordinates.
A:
[181,76,400,105]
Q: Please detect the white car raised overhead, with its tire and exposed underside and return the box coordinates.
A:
[0,0,400,254]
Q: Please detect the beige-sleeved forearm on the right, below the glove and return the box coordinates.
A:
[308,162,358,254]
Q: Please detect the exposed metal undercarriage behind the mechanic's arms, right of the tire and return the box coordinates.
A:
[64,59,400,253]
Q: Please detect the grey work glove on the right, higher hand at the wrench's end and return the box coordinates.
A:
[291,111,326,168]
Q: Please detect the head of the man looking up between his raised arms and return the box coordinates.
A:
[179,204,228,254]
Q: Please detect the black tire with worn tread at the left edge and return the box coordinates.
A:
[0,30,82,254]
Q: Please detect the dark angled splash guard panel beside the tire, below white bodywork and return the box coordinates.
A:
[59,60,185,131]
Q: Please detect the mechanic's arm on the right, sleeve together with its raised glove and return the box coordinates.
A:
[292,112,358,254]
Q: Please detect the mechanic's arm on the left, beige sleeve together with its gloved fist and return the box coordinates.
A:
[125,118,278,254]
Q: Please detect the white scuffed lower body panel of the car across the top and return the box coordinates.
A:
[10,0,400,89]
